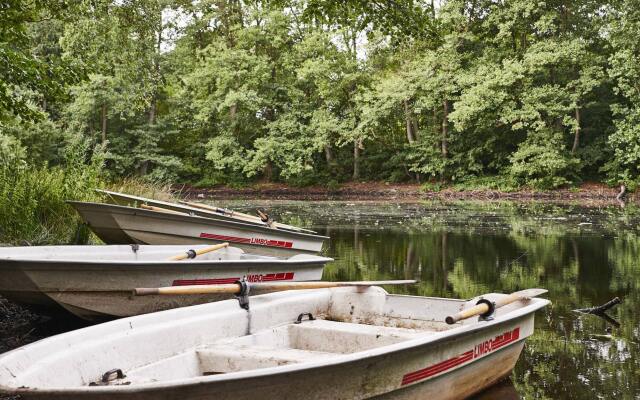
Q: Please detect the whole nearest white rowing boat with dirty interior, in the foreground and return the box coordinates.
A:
[0,287,549,400]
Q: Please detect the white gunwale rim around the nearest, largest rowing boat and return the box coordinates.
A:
[0,289,551,395]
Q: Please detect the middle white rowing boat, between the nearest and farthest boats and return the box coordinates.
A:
[0,245,331,320]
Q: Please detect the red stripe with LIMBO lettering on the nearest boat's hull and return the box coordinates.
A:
[402,327,520,386]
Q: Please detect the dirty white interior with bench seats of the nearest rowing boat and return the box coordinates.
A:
[0,287,518,390]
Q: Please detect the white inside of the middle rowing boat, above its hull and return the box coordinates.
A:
[0,245,290,263]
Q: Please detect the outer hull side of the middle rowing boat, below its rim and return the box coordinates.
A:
[0,246,329,321]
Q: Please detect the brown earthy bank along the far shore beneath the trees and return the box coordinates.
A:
[173,182,637,205]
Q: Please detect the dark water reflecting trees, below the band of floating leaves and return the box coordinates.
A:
[320,205,640,399]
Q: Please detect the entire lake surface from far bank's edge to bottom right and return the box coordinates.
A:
[217,201,640,400]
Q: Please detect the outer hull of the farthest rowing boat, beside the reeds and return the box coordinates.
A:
[69,202,328,256]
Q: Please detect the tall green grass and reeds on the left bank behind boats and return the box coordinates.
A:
[0,140,102,244]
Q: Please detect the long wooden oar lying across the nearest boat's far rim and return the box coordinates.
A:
[133,280,418,296]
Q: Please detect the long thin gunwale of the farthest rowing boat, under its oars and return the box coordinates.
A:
[67,200,330,241]
